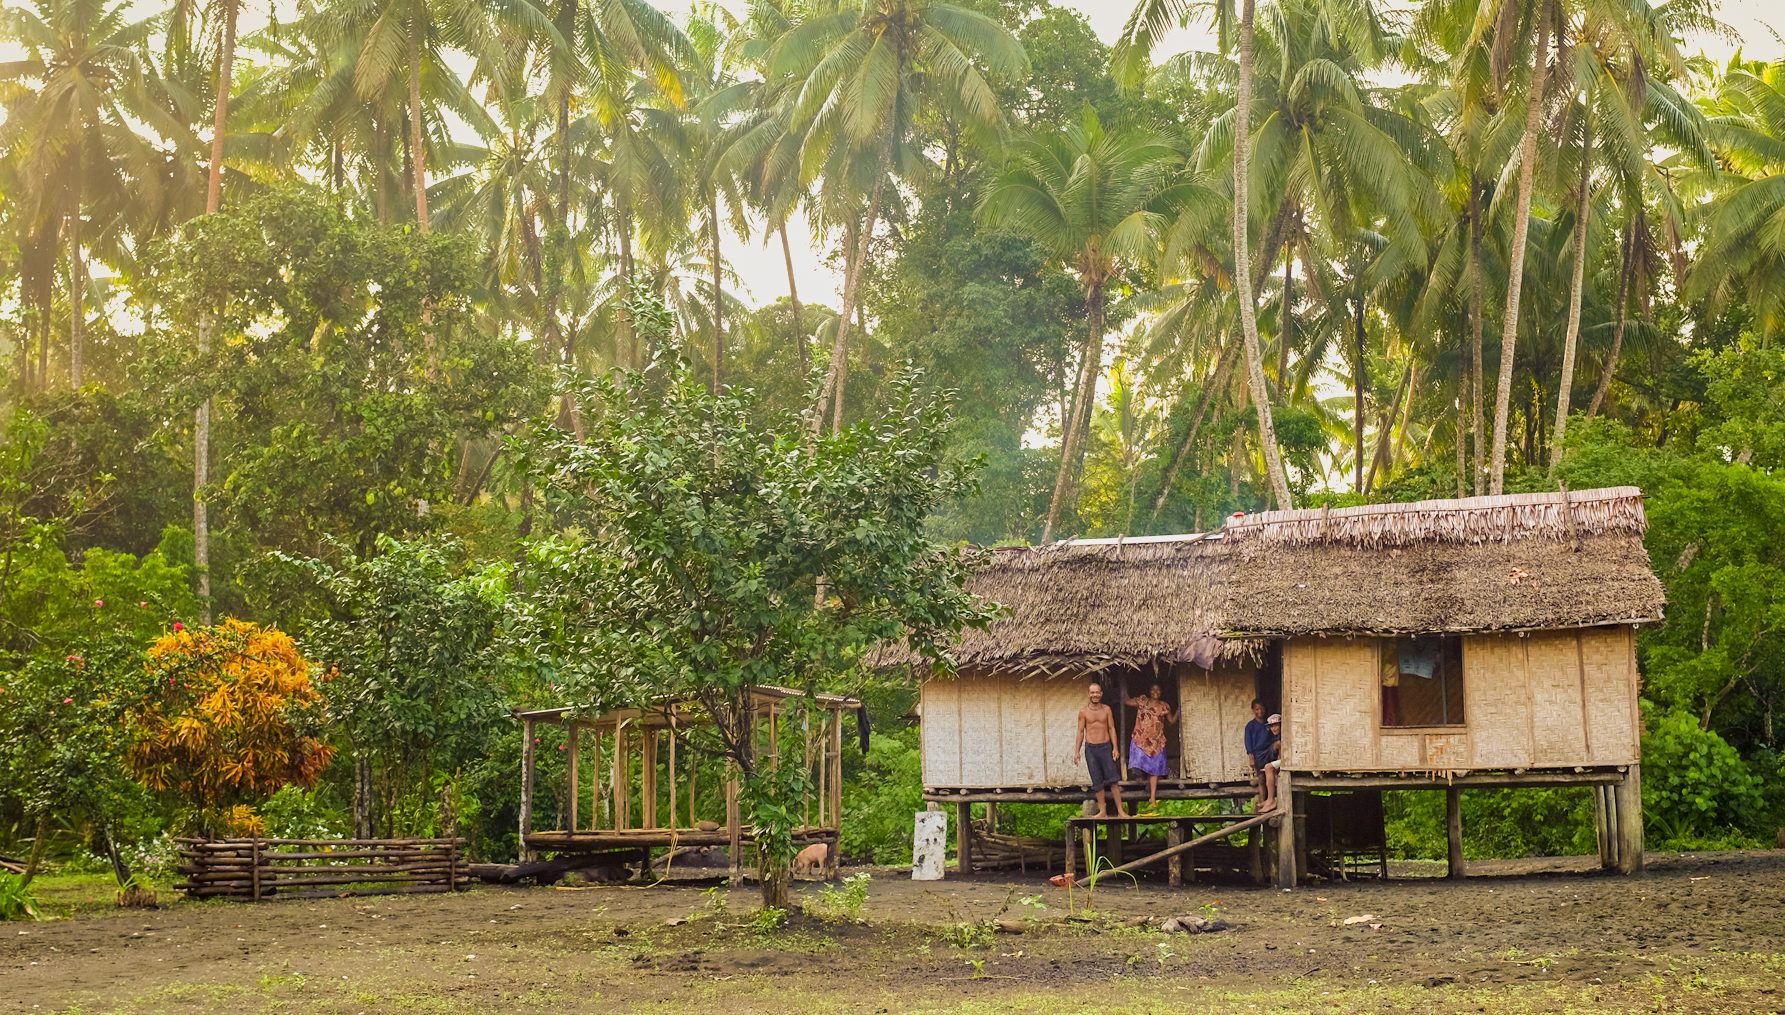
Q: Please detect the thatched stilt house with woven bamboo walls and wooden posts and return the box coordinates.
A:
[921,487,1662,883]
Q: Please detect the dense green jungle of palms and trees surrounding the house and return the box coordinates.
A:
[0,0,1785,878]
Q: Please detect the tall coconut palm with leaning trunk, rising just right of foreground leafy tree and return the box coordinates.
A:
[769,0,1026,432]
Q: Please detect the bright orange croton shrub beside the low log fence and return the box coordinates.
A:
[125,619,334,833]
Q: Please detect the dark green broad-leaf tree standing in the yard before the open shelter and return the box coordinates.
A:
[527,358,989,904]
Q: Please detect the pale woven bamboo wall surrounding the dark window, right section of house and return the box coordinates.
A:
[1283,626,1640,772]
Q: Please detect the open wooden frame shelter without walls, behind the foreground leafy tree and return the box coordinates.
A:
[514,685,862,876]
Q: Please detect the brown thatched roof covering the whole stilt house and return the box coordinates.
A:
[953,487,1662,674]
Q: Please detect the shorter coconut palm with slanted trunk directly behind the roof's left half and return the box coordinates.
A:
[980,109,1183,542]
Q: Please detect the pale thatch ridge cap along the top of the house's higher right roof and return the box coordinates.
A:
[1221,487,1648,549]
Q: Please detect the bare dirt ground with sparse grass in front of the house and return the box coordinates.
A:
[10,851,1785,1015]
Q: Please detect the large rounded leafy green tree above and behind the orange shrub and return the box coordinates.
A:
[153,191,544,574]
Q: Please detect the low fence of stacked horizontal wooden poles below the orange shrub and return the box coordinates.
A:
[175,838,471,899]
